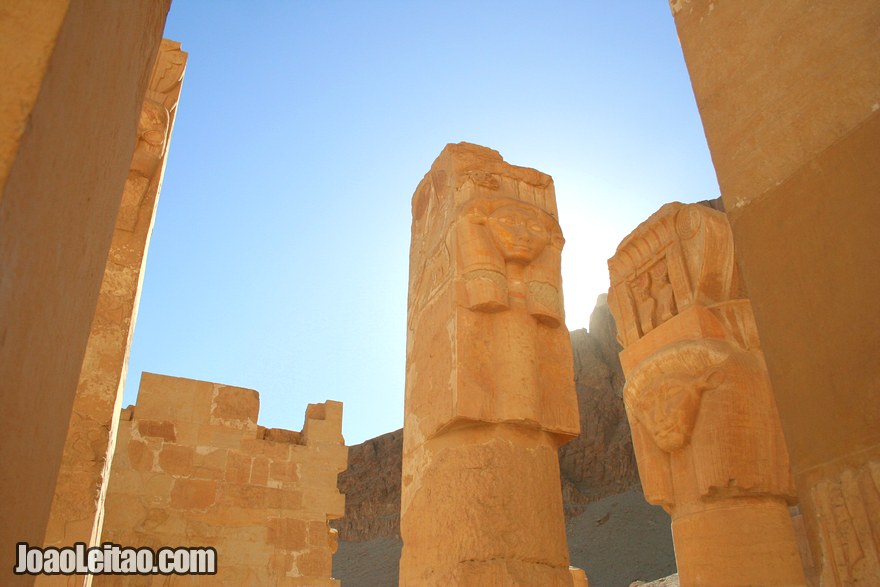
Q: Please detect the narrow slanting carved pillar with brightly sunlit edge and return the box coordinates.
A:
[37,39,186,564]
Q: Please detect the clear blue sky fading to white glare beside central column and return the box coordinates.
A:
[124,0,719,444]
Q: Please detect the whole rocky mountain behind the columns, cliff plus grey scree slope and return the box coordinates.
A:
[332,203,676,587]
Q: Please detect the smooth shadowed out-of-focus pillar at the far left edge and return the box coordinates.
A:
[0,0,170,585]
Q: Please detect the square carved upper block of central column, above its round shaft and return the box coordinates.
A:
[407,145,578,444]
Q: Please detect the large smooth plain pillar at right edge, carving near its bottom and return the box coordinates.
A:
[671,0,880,585]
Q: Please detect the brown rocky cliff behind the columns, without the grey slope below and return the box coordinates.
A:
[333,294,639,542]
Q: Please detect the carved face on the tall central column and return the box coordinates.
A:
[486,204,550,265]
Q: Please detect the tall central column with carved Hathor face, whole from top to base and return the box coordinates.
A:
[400,143,579,587]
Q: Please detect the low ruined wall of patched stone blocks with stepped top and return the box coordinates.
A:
[95,373,348,587]
